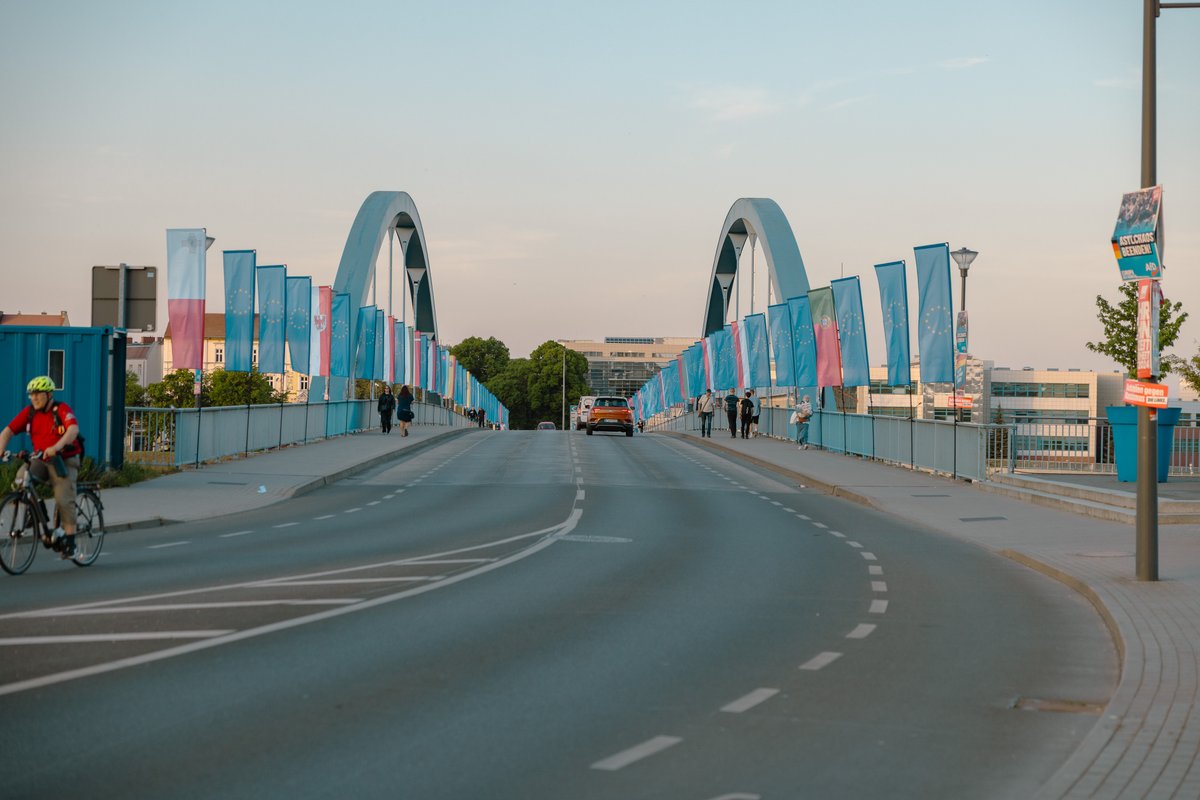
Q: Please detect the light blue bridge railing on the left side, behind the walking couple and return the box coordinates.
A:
[125,399,474,468]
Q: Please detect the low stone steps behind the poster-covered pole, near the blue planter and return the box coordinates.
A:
[974,474,1200,525]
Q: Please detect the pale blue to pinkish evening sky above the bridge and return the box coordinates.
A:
[0,0,1200,386]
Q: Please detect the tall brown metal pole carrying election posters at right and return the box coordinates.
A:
[1135,0,1158,581]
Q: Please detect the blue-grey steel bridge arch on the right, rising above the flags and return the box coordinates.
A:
[700,197,809,337]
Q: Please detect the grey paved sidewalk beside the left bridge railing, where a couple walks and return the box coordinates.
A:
[101,425,480,531]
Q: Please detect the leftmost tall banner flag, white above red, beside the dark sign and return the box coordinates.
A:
[167,228,206,369]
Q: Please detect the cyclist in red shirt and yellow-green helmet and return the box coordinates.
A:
[0,375,82,559]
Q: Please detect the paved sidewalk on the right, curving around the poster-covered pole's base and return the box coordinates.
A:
[666,431,1200,800]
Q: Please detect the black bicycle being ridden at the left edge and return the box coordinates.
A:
[0,451,104,575]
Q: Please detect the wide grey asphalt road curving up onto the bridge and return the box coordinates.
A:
[0,432,1116,800]
